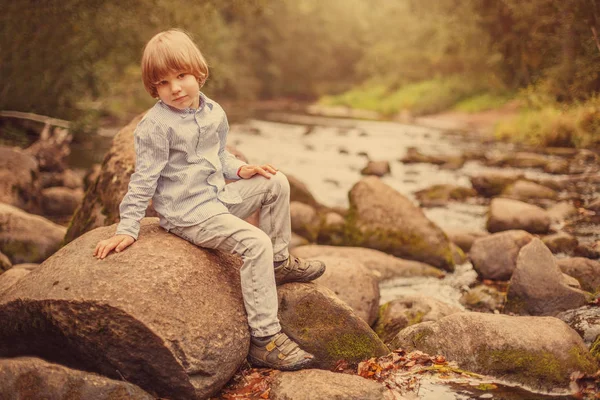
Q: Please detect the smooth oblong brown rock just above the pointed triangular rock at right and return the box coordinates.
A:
[487,198,550,233]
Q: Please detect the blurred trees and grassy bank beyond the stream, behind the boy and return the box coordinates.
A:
[0,0,600,147]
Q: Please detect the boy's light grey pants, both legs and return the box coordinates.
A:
[171,172,291,337]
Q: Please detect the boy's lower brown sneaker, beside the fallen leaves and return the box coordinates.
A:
[248,332,314,371]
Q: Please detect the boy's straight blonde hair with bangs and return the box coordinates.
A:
[142,29,208,98]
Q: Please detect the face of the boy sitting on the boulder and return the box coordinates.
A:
[156,71,200,110]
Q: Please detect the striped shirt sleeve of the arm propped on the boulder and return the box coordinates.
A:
[116,120,169,240]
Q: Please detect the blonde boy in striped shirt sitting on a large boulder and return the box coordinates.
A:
[94,30,325,370]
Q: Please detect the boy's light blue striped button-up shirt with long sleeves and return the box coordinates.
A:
[116,93,245,239]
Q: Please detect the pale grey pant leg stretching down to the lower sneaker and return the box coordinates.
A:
[171,214,281,337]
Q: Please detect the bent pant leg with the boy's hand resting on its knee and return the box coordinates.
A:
[225,171,292,261]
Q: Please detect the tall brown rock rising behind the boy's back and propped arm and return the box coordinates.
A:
[64,114,146,243]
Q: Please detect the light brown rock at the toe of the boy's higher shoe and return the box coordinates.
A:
[314,256,379,325]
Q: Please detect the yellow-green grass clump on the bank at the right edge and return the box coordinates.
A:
[495,97,600,148]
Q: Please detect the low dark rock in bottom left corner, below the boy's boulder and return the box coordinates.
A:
[0,357,155,400]
